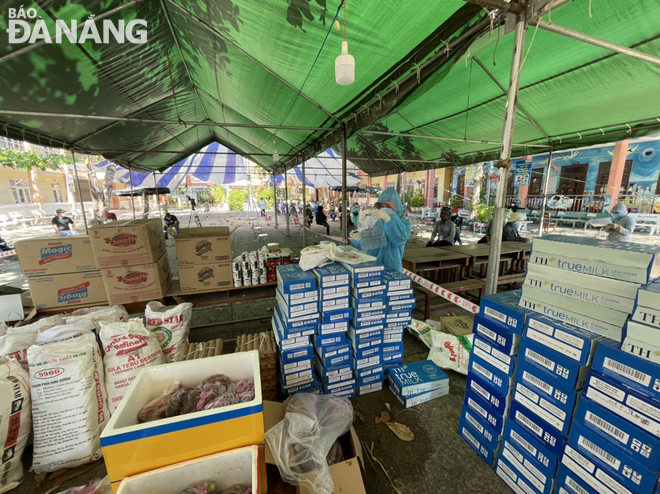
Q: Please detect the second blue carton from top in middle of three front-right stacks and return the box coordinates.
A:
[518,338,590,393]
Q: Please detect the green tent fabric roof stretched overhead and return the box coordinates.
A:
[0,0,660,178]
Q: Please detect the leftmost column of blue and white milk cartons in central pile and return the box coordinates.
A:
[272,264,320,394]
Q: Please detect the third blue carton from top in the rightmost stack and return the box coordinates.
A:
[574,398,660,472]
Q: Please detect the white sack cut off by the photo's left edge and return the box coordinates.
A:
[0,358,32,493]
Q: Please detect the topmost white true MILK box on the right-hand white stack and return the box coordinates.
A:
[532,235,660,284]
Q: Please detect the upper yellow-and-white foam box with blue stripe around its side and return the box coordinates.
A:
[101,350,264,483]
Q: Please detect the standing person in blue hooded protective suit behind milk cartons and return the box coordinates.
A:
[351,188,412,272]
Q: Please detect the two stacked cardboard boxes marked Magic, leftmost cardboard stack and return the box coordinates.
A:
[16,236,106,309]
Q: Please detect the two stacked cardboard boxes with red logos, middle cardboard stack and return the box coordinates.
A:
[89,219,172,305]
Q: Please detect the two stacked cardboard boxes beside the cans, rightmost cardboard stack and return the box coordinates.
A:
[173,226,233,293]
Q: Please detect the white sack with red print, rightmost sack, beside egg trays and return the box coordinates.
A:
[144,302,192,362]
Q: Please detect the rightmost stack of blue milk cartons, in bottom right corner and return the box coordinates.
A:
[557,339,660,494]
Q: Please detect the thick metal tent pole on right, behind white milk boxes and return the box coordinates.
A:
[486,14,527,295]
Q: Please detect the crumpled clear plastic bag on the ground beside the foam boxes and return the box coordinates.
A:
[266,393,353,494]
